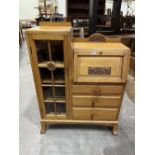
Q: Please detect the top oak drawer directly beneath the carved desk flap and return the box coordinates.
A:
[72,85,123,95]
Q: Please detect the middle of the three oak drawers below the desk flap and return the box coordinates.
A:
[72,95,121,107]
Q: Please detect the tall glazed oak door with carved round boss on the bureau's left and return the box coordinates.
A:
[29,34,69,119]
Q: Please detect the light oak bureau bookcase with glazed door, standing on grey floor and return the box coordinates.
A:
[26,26,130,134]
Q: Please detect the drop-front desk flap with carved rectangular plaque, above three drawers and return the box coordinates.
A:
[74,49,129,83]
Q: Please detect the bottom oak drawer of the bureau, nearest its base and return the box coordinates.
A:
[72,108,118,121]
